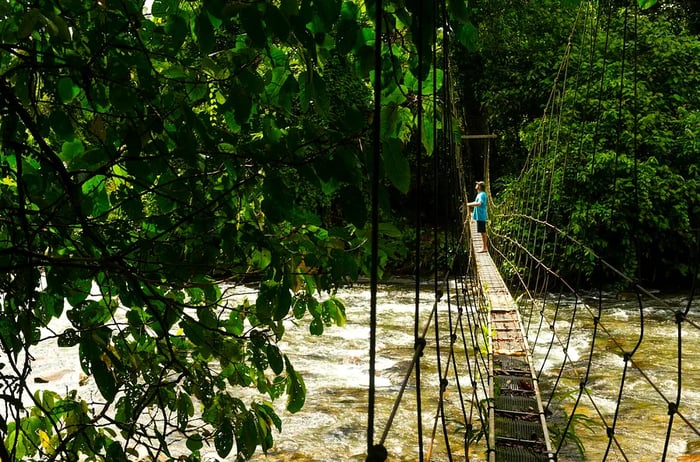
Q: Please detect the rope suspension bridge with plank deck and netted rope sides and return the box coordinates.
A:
[366,2,700,462]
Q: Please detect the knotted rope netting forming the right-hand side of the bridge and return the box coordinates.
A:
[490,5,700,460]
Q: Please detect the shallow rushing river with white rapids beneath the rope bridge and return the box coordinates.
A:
[20,284,700,462]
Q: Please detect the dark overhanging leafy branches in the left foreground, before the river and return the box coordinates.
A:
[0,0,473,461]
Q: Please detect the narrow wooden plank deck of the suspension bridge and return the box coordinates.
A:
[471,221,555,462]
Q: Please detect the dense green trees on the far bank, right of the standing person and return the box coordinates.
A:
[465,2,700,288]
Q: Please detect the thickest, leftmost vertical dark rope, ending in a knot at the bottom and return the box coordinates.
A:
[366,0,387,462]
